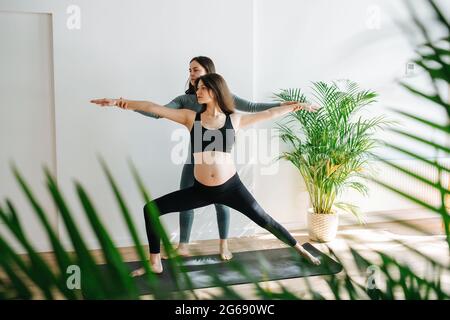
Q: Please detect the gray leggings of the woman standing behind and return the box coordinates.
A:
[180,159,230,243]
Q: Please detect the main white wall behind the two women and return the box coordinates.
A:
[0,0,448,254]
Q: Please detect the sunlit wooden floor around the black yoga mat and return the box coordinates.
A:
[5,218,450,299]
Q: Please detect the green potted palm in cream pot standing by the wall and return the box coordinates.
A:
[275,80,387,242]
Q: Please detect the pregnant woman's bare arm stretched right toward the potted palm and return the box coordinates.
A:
[233,103,319,129]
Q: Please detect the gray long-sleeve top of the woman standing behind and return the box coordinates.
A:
[136,94,280,119]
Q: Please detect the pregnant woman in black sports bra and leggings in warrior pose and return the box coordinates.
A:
[91,73,320,276]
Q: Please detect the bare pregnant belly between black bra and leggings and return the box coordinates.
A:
[194,151,236,186]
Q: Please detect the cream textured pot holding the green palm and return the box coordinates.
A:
[308,208,339,242]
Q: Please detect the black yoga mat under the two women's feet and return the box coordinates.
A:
[100,243,342,294]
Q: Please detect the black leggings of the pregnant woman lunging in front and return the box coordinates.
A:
[144,173,297,253]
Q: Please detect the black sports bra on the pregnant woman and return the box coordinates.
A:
[190,112,235,153]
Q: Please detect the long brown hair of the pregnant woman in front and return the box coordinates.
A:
[195,73,235,114]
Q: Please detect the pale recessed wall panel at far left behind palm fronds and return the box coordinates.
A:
[0,11,58,249]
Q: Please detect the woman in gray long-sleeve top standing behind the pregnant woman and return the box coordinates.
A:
[135,56,295,260]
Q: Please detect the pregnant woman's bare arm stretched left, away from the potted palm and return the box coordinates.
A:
[91,98,195,127]
